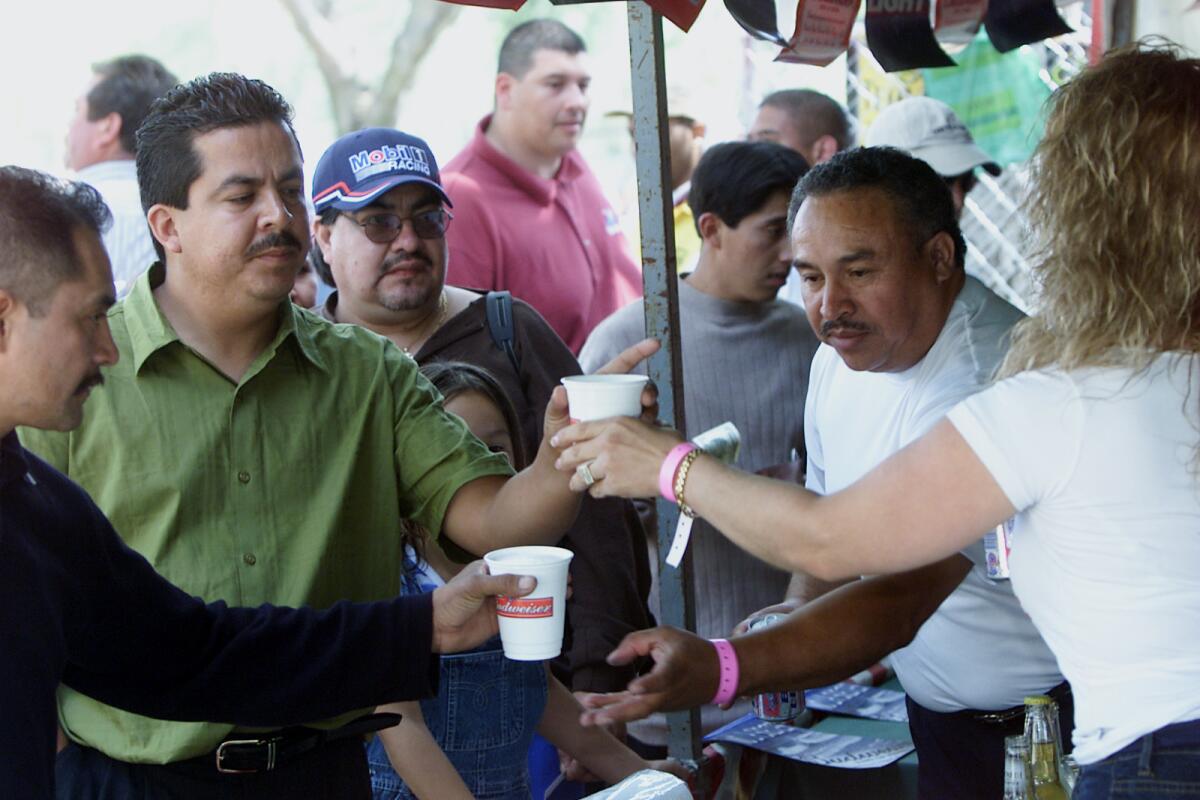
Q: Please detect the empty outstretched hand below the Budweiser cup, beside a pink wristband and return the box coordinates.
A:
[580,627,720,726]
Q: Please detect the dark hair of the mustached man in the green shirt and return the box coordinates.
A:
[137,72,300,259]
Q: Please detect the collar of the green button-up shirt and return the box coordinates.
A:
[119,261,326,374]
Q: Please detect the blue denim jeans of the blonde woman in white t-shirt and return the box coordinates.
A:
[1072,720,1200,800]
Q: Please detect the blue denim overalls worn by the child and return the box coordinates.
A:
[367,638,546,800]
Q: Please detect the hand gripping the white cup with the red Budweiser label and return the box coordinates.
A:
[433,561,538,652]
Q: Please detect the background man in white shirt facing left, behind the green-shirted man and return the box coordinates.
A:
[66,55,179,297]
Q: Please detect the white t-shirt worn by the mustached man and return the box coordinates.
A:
[805,277,1062,712]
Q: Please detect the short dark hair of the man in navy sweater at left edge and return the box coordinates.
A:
[0,167,113,317]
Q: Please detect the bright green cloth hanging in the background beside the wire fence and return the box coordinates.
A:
[922,32,1050,164]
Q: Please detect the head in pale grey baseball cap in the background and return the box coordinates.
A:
[866,97,1000,218]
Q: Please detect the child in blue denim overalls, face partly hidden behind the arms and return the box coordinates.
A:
[367,362,682,800]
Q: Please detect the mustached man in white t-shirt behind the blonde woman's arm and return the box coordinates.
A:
[790,148,1070,800]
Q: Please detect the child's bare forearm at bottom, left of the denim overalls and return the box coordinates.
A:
[377,703,472,800]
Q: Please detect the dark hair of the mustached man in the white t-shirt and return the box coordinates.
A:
[787,148,967,269]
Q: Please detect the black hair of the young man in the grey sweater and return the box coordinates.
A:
[688,142,809,233]
